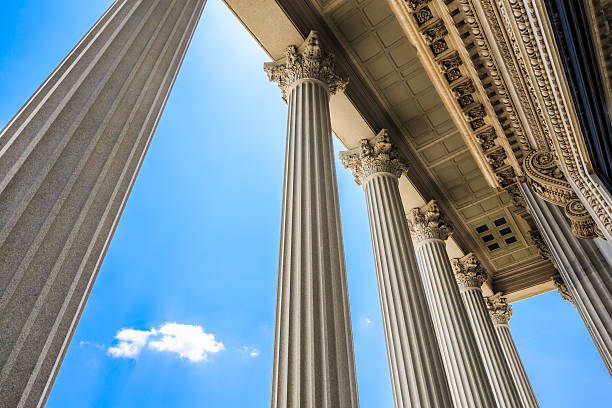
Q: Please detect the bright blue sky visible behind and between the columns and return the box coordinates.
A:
[0,0,612,408]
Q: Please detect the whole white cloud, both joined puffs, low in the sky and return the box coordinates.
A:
[107,323,225,362]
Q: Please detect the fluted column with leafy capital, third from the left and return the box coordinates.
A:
[340,130,452,408]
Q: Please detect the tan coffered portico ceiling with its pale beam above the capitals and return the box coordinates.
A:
[225,0,555,300]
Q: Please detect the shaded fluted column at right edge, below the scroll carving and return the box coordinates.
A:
[520,183,612,375]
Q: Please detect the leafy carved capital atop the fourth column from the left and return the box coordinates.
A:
[407,200,453,242]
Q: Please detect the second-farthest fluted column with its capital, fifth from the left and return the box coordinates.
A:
[451,253,524,408]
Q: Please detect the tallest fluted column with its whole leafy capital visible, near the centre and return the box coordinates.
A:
[264,31,359,408]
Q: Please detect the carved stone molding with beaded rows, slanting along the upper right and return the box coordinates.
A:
[474,0,612,239]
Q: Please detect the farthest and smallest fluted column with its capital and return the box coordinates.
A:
[486,295,538,407]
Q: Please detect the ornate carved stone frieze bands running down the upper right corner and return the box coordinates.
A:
[490,0,612,238]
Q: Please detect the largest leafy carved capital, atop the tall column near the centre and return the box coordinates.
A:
[264,30,348,102]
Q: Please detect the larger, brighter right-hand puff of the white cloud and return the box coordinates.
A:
[149,323,225,362]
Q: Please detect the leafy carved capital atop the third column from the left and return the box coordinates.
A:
[340,129,408,185]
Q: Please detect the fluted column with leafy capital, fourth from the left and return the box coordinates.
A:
[408,201,497,408]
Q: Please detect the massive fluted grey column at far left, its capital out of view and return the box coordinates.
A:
[0,0,205,407]
